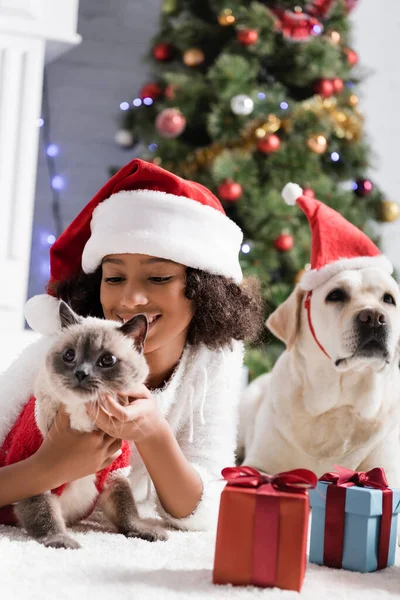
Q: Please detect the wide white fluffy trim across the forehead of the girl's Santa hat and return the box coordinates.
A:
[82,190,243,283]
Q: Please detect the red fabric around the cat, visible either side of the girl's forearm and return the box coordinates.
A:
[0,397,130,525]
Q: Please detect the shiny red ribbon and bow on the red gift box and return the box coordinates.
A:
[222,466,318,587]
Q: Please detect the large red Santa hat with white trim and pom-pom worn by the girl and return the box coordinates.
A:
[25,159,243,334]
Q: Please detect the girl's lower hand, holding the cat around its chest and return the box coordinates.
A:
[34,406,122,489]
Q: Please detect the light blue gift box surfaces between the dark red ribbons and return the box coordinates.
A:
[309,481,400,573]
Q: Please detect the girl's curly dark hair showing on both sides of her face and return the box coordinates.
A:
[48,266,264,350]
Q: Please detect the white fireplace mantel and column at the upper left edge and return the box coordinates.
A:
[0,0,81,336]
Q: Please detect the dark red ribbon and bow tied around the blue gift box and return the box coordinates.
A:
[319,465,393,569]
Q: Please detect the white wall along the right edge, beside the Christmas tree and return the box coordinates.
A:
[353,0,400,271]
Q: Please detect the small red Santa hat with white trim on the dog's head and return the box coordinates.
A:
[282,183,393,291]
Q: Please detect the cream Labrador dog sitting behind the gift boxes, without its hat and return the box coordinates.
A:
[238,267,400,487]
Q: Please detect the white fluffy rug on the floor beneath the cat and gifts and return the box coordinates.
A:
[0,508,400,600]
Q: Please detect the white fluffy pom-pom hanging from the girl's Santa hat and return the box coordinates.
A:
[24,294,61,335]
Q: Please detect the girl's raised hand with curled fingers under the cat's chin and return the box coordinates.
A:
[86,385,167,443]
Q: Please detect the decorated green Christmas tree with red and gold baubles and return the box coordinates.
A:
[112,0,399,377]
